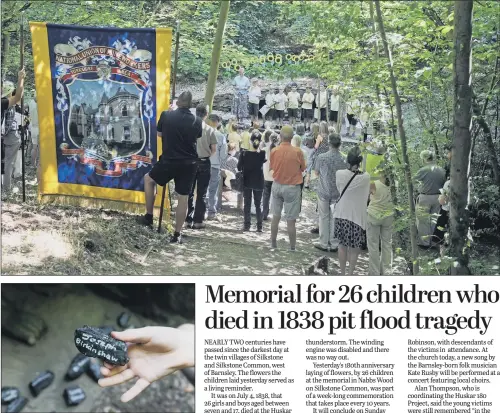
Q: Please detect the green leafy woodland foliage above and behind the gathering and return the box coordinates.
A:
[2,0,500,266]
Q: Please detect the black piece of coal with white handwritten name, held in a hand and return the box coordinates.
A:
[75,325,129,366]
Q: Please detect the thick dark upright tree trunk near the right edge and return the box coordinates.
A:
[450,0,473,275]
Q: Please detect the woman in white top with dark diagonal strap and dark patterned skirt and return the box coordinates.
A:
[333,146,370,275]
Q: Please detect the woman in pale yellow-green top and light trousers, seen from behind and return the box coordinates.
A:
[366,166,394,275]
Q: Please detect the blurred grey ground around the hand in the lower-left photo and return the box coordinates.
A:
[2,284,194,413]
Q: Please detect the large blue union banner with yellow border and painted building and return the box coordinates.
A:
[30,23,172,216]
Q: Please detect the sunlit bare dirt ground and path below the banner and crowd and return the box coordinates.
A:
[1,164,500,275]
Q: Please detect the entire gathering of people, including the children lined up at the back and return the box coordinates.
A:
[2,69,451,275]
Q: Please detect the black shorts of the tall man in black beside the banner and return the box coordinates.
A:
[149,159,198,195]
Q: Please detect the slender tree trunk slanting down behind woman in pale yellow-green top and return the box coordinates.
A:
[375,0,419,275]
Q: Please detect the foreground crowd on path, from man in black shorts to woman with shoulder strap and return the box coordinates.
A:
[135,83,376,274]
